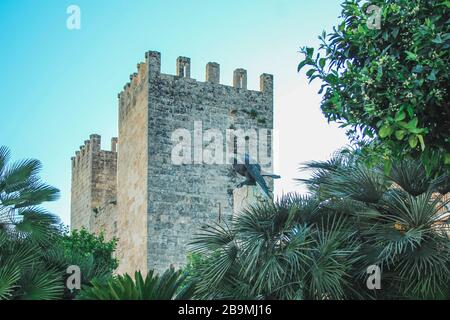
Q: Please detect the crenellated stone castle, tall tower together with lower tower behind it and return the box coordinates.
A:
[71,51,273,273]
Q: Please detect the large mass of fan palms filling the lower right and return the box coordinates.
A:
[192,150,450,300]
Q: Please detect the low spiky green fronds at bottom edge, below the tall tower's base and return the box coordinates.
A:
[78,268,193,300]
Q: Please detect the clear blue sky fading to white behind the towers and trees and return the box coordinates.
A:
[0,0,346,224]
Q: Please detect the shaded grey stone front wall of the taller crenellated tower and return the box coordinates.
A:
[148,51,273,271]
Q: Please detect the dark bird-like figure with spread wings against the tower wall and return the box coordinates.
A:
[233,154,281,198]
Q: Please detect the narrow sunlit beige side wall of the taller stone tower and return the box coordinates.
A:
[117,57,148,274]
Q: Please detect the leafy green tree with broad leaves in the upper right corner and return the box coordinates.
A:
[298,0,450,175]
